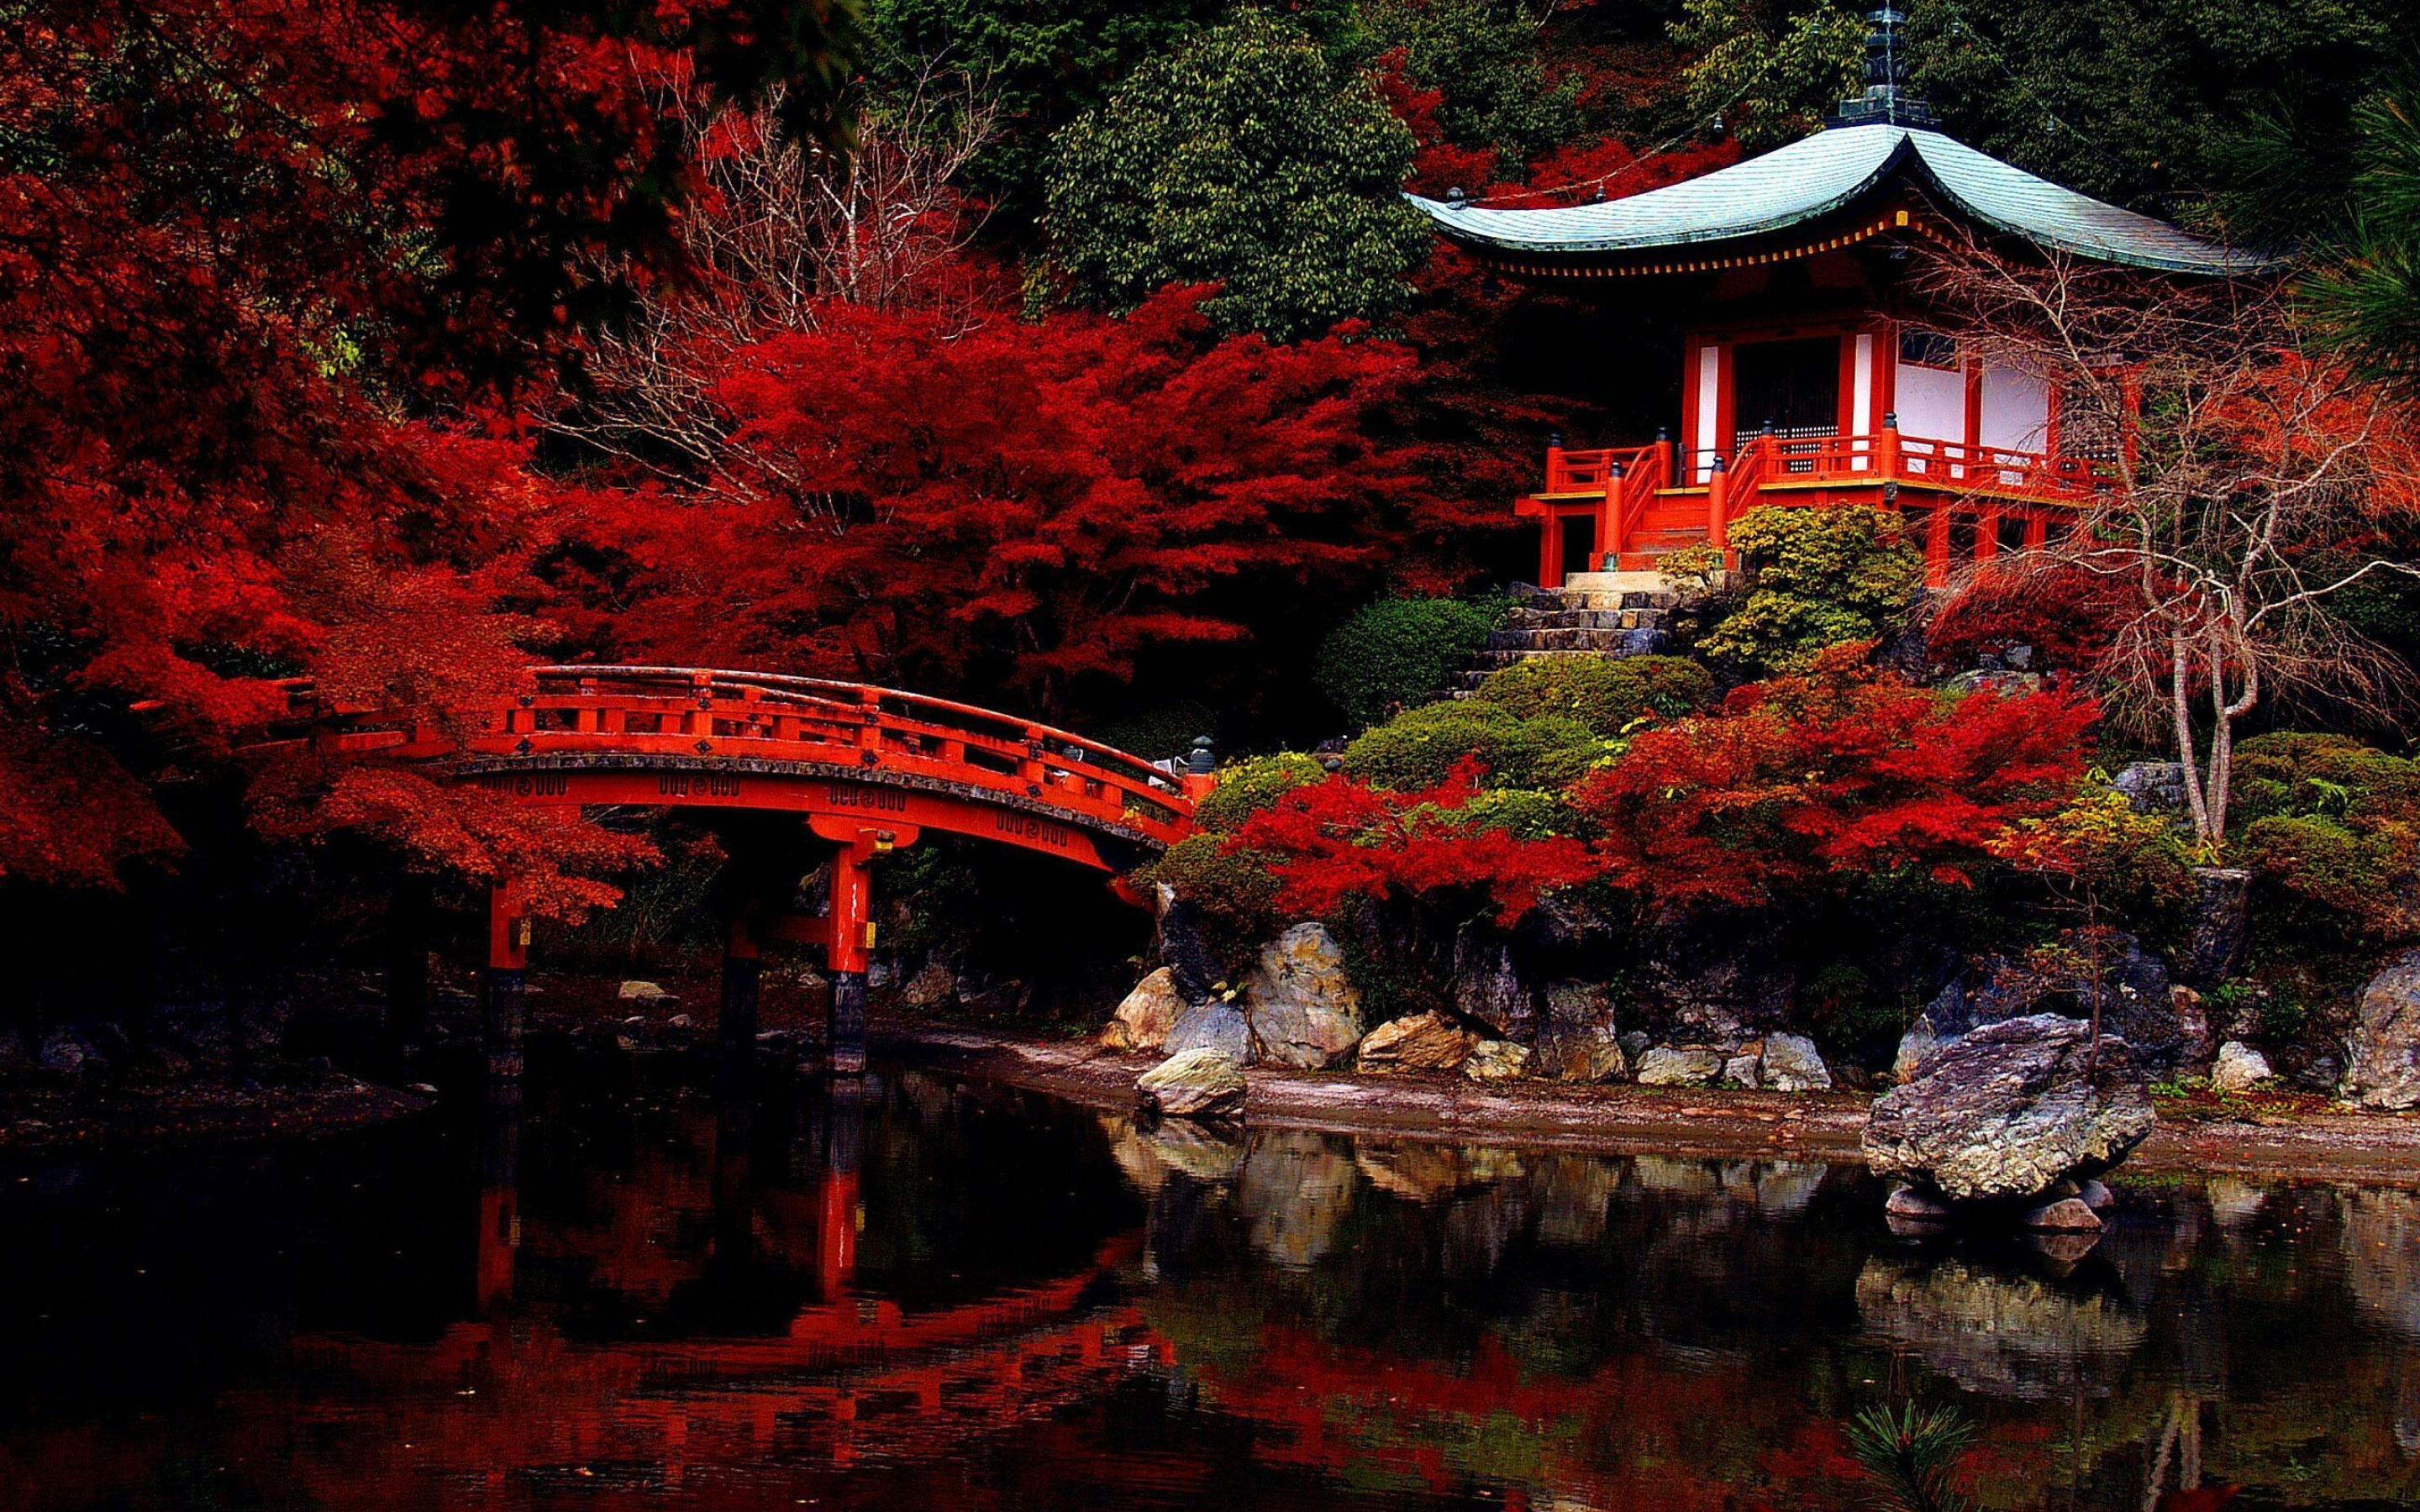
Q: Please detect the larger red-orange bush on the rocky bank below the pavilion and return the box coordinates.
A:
[1576,646,2098,907]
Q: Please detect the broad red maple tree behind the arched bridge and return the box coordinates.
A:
[556,291,1430,714]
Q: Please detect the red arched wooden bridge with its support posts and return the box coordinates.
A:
[313,665,1213,1069]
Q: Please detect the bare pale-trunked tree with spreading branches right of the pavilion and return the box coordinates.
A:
[1919,242,2420,847]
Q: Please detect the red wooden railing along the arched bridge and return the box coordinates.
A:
[295,665,1193,844]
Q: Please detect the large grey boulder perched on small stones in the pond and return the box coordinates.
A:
[1864,1014,2151,1202]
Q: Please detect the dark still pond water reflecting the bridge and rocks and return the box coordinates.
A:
[0,1069,2420,1512]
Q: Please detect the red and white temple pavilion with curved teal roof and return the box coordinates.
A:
[1413,10,2265,588]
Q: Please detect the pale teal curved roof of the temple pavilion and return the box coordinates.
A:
[1411,123,2270,276]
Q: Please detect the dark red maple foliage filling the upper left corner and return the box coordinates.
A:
[0,0,851,885]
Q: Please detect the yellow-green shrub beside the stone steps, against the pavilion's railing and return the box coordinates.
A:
[1697,506,1924,675]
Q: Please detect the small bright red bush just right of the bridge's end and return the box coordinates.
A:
[1229,757,1597,924]
